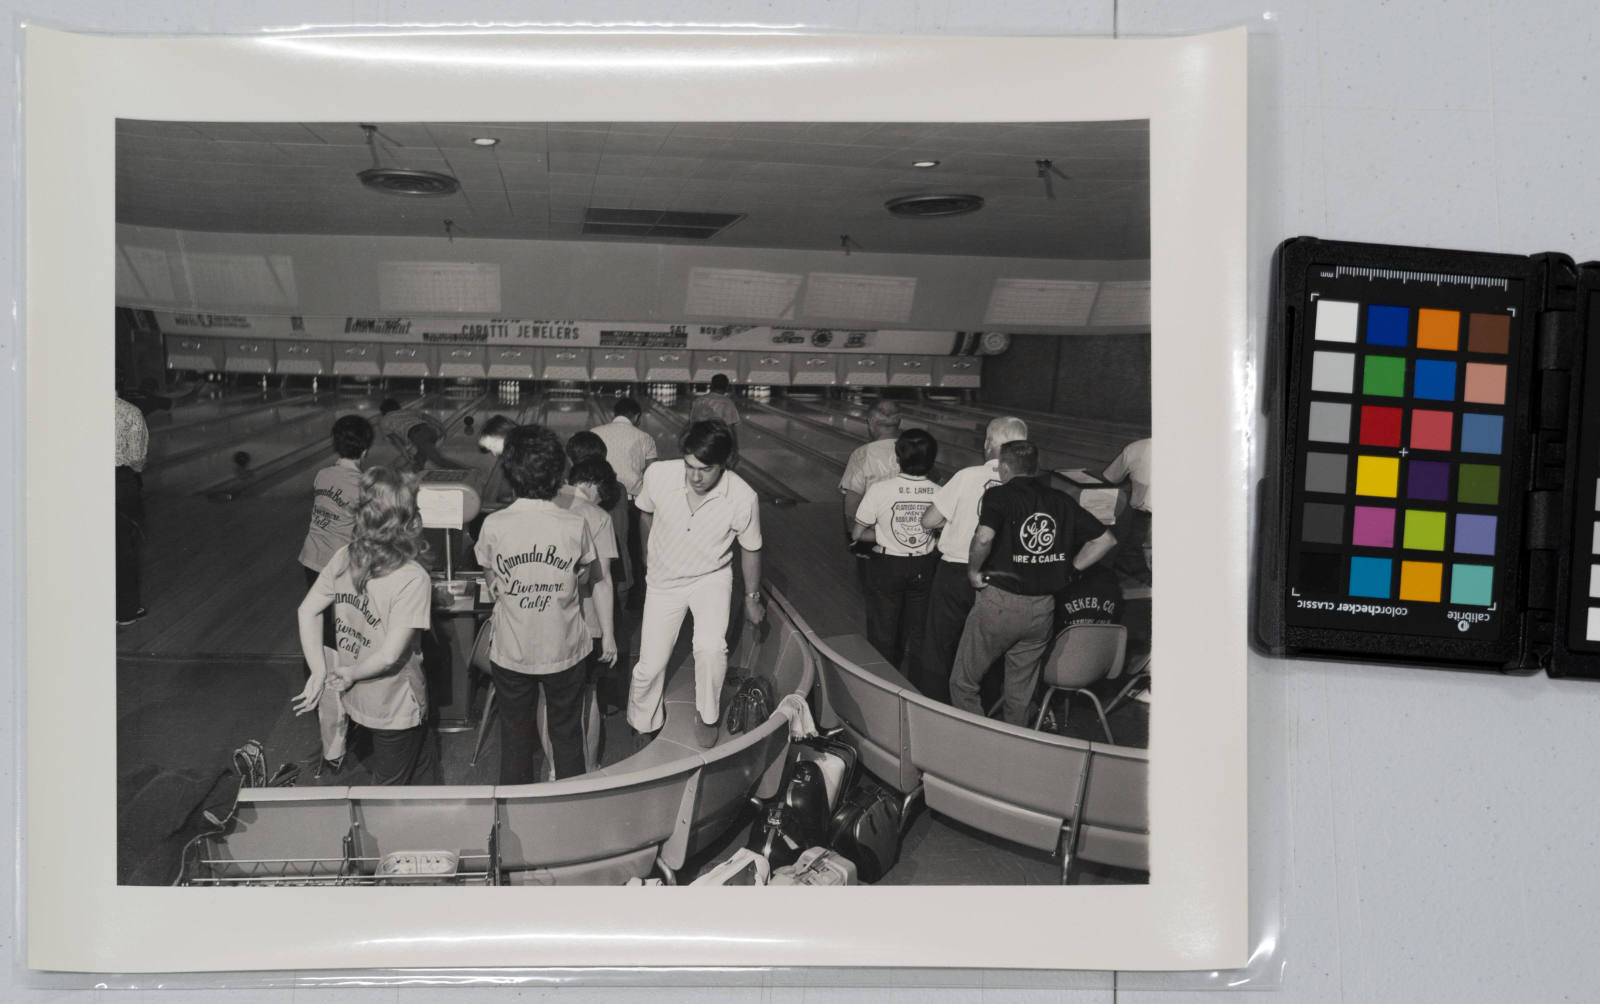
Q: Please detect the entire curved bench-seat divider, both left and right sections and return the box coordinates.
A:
[189,588,1149,884]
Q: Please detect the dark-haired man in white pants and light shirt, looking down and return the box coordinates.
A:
[627,419,766,747]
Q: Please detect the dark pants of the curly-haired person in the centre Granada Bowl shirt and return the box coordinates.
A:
[490,660,587,785]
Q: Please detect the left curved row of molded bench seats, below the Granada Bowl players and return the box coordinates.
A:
[198,590,816,884]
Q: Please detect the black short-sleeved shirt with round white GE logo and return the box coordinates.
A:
[978,476,1106,596]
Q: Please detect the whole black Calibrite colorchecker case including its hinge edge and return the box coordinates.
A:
[1256,238,1600,676]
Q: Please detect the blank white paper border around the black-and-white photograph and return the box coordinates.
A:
[22,27,1253,972]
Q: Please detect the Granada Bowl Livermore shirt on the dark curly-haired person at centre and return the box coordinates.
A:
[474,499,597,676]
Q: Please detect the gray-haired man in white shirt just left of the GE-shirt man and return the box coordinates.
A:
[912,416,1027,703]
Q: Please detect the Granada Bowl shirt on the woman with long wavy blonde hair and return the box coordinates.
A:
[310,547,434,729]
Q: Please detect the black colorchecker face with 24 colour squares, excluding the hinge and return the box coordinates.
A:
[1285,249,1531,639]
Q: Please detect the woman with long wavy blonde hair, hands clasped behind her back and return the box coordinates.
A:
[294,467,438,785]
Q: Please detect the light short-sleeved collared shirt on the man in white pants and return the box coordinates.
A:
[637,460,762,585]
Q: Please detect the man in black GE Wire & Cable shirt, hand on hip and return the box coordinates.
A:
[950,440,1117,726]
